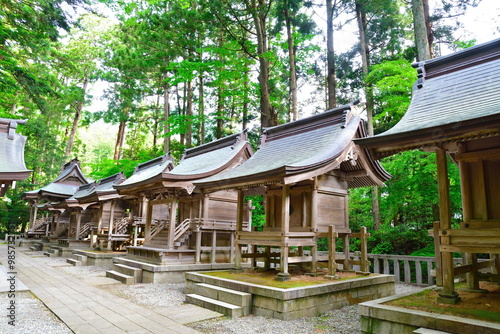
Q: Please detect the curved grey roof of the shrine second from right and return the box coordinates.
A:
[194,104,390,190]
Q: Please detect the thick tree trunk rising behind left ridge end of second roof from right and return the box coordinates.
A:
[251,0,278,128]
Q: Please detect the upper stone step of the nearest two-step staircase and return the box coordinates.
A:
[193,283,252,315]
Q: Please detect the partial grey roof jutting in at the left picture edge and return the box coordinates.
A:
[0,118,31,196]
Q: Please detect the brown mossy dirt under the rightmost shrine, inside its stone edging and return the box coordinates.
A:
[387,282,500,323]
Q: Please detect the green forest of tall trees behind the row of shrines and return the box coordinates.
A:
[0,0,500,255]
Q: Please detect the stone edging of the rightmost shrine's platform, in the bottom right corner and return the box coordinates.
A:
[359,287,500,334]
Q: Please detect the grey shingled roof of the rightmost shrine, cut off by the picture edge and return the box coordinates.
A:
[356,39,500,158]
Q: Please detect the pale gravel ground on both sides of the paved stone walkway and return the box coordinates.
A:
[11,252,419,334]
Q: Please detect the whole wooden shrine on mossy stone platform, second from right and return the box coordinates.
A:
[195,104,390,280]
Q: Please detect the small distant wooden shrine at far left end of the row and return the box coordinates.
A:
[23,159,88,237]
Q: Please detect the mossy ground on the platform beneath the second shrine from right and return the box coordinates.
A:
[203,269,367,289]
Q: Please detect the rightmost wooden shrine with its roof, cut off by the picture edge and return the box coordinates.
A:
[356,39,500,303]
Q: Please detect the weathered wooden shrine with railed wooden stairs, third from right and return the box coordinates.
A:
[114,131,252,264]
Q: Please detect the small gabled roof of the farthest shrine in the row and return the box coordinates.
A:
[23,159,89,199]
